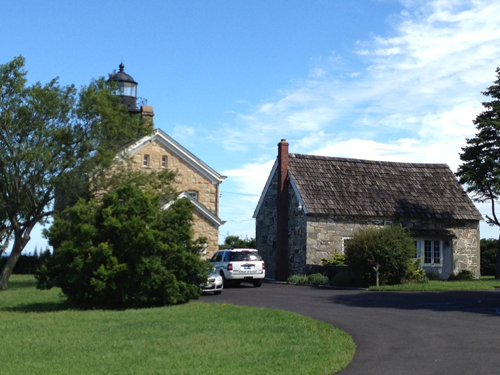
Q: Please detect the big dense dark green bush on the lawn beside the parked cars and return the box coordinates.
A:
[36,184,208,308]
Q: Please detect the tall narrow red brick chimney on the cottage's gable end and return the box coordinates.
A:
[276,139,289,281]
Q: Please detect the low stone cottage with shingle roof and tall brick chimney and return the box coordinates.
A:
[254,140,482,280]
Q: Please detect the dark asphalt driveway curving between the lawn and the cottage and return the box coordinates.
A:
[201,284,500,375]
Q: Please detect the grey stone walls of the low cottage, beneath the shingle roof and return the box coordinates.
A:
[256,170,480,278]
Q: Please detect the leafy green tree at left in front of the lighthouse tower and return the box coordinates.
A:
[0,57,150,290]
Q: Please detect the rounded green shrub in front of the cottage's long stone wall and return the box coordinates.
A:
[345,226,417,285]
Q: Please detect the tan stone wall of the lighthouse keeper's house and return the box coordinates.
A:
[132,141,219,257]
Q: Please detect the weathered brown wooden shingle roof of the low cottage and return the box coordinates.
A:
[288,154,482,220]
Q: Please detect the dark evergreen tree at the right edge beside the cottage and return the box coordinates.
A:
[456,68,500,279]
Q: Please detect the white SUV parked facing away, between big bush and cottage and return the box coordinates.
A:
[210,249,266,288]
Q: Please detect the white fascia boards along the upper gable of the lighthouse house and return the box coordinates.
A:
[117,129,227,184]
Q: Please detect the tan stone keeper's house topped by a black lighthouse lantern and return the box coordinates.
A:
[110,64,226,257]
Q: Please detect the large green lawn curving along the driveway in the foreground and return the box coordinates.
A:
[0,275,355,375]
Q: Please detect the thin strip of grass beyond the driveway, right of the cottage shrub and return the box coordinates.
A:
[370,276,500,292]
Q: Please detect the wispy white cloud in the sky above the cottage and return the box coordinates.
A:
[221,0,500,238]
